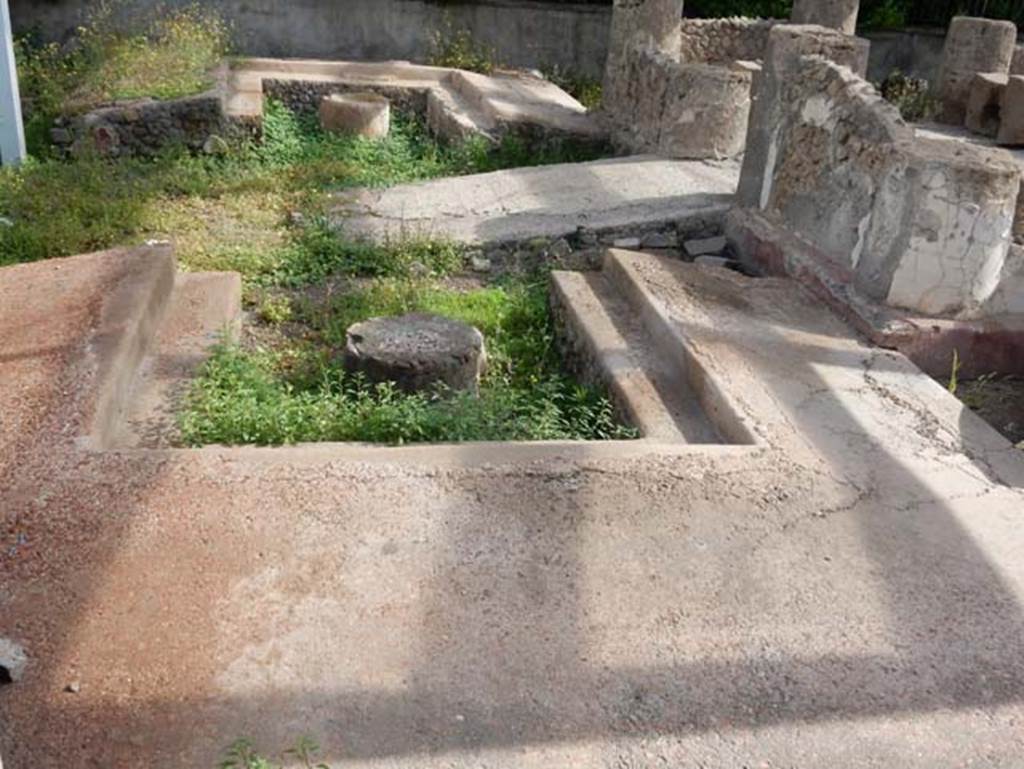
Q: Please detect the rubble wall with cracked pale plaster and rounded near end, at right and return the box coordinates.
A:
[740,38,1020,318]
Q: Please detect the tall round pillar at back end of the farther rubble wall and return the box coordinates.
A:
[603,0,683,122]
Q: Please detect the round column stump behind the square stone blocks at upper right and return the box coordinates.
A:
[937,16,1017,126]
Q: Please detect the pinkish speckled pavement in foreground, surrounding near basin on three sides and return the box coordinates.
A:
[0,247,1024,769]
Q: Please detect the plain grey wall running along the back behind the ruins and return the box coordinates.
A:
[11,0,944,81]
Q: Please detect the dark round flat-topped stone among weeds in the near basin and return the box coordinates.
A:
[345,313,486,393]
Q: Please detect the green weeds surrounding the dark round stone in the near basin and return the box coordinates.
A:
[179,279,636,445]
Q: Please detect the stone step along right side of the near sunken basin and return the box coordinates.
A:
[552,272,723,443]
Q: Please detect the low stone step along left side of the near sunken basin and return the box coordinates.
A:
[112,272,242,448]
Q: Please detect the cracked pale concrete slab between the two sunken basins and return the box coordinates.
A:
[332,156,737,244]
